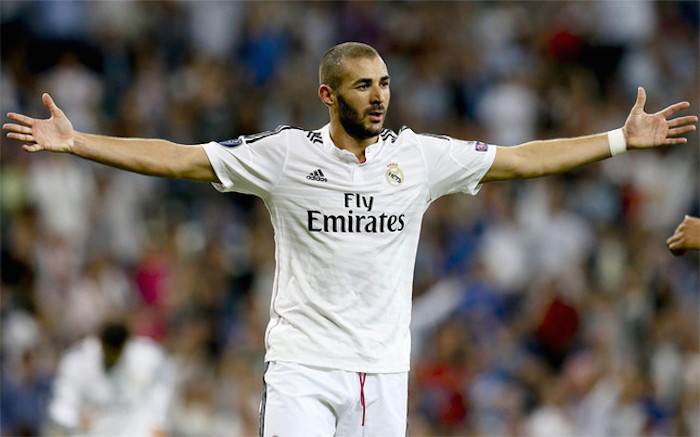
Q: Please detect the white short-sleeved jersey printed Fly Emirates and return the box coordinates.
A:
[204,125,496,373]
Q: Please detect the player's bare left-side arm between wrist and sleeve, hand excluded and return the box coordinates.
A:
[71,132,216,180]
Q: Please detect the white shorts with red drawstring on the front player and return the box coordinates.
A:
[260,361,408,437]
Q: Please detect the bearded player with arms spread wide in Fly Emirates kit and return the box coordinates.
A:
[4,43,697,437]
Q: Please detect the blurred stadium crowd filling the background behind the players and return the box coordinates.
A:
[0,1,700,436]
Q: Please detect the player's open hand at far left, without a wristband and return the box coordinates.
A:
[2,93,75,152]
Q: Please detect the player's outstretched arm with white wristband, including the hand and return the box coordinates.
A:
[481,87,698,182]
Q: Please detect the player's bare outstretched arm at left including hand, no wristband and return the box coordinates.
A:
[3,93,218,182]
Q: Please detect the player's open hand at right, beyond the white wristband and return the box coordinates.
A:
[623,87,698,149]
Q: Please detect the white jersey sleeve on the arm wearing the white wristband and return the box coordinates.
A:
[418,134,496,200]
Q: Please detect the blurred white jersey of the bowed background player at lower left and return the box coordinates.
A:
[48,337,175,437]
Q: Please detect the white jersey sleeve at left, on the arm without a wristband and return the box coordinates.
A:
[202,129,287,197]
